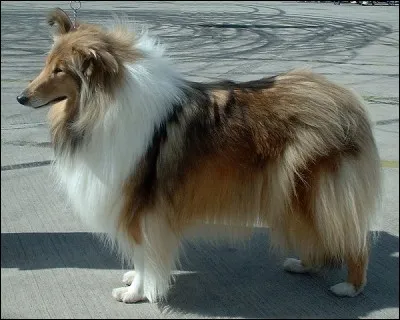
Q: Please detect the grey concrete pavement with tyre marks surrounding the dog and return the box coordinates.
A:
[1,1,399,318]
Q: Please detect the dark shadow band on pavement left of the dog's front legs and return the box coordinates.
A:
[1,232,121,270]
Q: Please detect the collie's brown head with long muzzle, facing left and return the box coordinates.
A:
[17,8,137,109]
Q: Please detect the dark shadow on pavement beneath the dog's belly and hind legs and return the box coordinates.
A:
[160,232,399,319]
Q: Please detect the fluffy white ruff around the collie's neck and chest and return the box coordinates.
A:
[56,36,181,251]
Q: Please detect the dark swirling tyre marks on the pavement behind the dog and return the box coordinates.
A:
[1,2,391,67]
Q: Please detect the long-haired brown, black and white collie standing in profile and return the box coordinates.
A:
[17,9,380,303]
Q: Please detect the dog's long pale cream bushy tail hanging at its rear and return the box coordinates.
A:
[315,137,381,261]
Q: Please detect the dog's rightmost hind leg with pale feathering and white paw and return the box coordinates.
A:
[316,151,380,297]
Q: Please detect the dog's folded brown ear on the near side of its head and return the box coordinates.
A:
[82,49,118,77]
